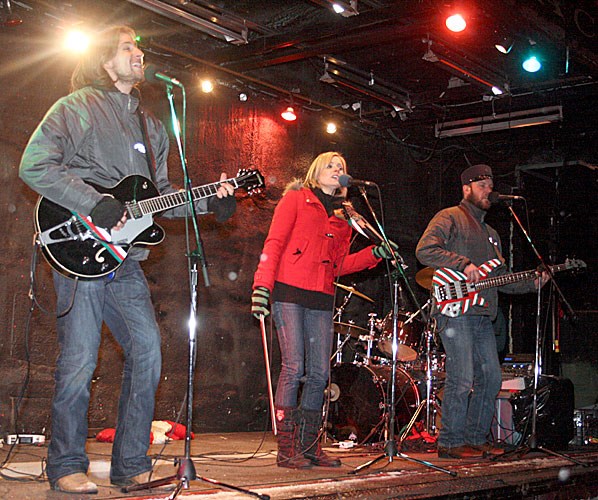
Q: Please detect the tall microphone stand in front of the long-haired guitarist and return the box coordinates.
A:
[122,80,270,500]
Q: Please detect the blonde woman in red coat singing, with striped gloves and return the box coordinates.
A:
[251,152,398,469]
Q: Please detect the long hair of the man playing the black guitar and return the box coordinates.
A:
[71,26,135,92]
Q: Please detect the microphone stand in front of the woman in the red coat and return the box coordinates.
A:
[349,186,457,476]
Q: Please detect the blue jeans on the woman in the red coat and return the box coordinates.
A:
[272,302,334,411]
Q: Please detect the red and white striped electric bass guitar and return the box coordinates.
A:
[432,259,586,318]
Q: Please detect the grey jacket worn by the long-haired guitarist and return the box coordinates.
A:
[19,83,235,259]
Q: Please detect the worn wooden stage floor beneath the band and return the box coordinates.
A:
[0,432,598,500]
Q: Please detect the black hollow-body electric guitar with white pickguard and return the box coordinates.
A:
[35,170,264,279]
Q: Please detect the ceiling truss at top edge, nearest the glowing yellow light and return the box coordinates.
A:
[127,0,248,45]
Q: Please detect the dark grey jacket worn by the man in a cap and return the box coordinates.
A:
[415,200,534,319]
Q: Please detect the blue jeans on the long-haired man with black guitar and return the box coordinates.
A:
[47,259,162,484]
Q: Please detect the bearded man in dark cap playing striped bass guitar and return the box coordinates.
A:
[416,165,548,458]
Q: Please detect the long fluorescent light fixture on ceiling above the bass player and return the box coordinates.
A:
[434,106,563,139]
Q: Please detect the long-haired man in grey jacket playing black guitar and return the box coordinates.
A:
[19,26,235,494]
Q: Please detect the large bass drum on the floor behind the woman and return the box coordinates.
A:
[328,363,419,443]
